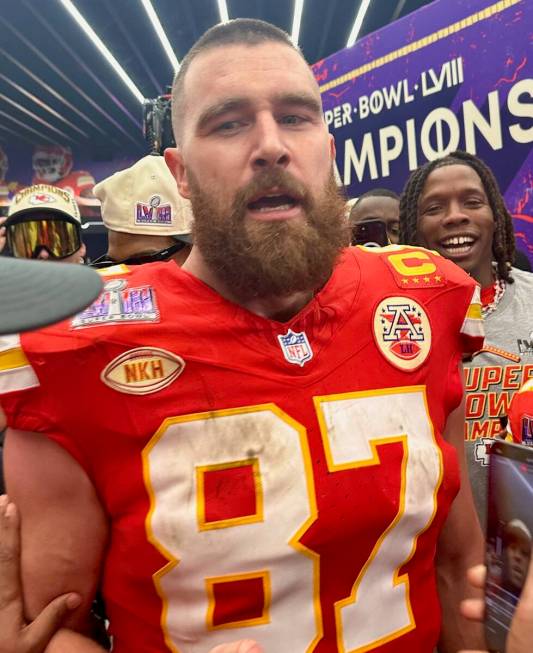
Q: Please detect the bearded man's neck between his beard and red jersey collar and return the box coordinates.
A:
[182,247,314,322]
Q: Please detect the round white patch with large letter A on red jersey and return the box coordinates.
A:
[374,297,431,372]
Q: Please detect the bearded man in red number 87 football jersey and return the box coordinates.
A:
[0,19,482,653]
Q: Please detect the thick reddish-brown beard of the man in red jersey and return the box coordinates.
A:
[188,169,349,300]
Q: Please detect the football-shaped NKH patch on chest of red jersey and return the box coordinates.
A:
[100,347,185,395]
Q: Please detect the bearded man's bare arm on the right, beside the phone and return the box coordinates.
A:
[437,392,485,653]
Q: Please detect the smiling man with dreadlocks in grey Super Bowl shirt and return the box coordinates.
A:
[400,152,533,524]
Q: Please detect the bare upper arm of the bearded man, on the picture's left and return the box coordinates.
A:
[4,430,108,653]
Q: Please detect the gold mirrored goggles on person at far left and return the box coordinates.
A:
[5,215,82,259]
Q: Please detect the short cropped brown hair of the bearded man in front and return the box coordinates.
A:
[172,18,307,143]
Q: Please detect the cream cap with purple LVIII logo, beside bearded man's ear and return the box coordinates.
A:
[94,154,192,240]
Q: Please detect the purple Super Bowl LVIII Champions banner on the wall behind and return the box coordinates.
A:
[313,0,533,261]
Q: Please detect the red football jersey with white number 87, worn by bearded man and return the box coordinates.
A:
[0,246,482,653]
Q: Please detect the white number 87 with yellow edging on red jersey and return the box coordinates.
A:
[143,386,442,653]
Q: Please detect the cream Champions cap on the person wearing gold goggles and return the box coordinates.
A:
[8,184,81,224]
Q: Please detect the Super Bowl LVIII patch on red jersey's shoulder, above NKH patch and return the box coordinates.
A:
[70,279,159,329]
